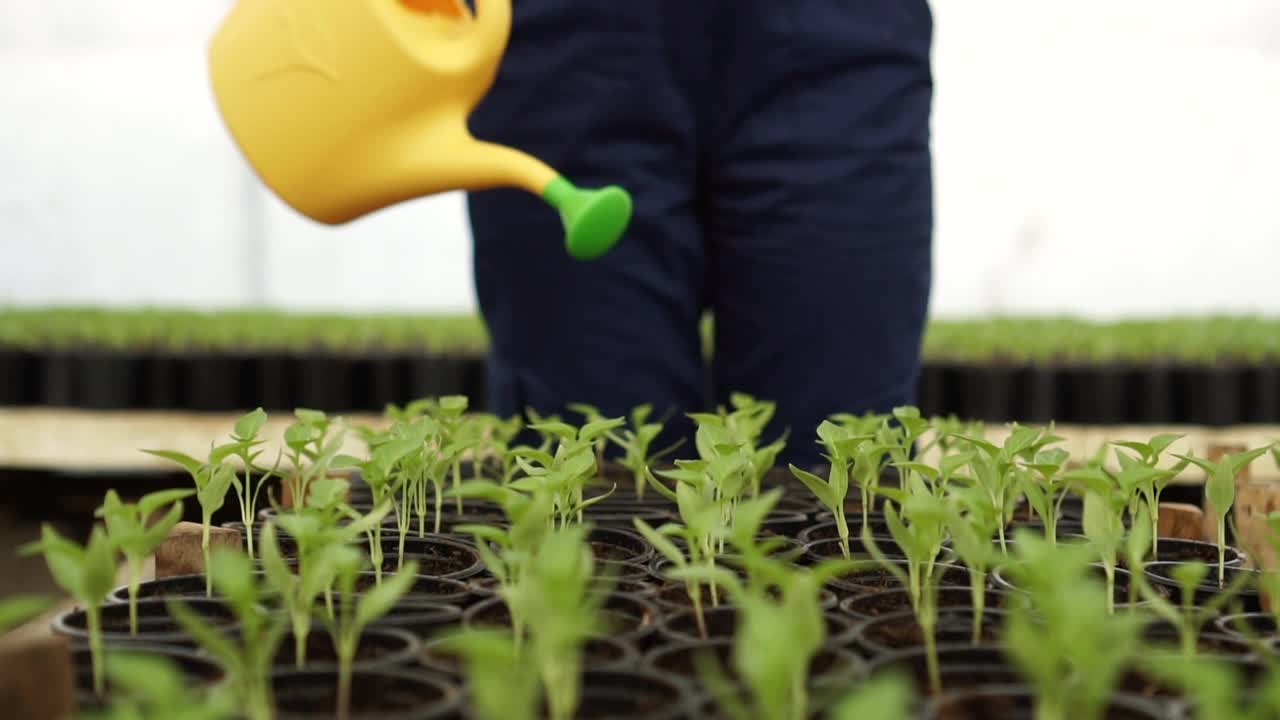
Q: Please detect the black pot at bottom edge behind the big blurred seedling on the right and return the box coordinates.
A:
[922,685,1167,720]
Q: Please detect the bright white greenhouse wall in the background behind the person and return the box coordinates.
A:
[0,0,1280,316]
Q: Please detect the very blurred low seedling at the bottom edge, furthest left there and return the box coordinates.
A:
[79,651,237,720]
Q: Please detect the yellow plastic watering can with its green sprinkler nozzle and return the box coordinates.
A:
[209,0,631,260]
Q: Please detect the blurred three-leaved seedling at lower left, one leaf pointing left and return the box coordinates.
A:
[168,547,288,720]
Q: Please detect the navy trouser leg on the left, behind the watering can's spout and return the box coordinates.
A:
[468,0,707,445]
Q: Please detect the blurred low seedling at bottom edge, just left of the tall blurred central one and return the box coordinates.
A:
[440,628,541,720]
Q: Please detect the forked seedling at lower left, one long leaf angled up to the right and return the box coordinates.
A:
[316,546,417,720]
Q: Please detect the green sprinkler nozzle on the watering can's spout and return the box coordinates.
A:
[543,177,631,260]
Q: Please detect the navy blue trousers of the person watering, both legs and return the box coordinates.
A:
[468,0,933,464]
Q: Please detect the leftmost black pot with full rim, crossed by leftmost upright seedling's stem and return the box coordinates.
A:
[52,598,238,647]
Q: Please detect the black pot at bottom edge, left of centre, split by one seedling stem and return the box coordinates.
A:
[271,669,462,720]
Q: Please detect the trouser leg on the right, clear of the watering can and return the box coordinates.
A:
[708,0,933,464]
